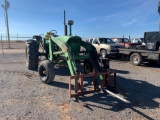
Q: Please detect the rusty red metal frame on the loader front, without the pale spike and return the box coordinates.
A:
[69,69,116,98]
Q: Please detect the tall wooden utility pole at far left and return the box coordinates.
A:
[2,0,11,48]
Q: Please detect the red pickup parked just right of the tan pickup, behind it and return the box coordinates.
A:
[111,38,131,48]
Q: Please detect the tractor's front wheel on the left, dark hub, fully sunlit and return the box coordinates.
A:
[38,60,55,84]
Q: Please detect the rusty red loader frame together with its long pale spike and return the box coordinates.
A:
[68,69,130,103]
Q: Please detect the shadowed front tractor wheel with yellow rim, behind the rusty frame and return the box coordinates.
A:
[84,60,93,74]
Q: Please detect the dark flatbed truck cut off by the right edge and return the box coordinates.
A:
[119,32,160,65]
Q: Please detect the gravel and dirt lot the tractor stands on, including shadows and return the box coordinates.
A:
[0,41,160,120]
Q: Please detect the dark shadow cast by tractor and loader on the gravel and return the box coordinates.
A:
[75,76,160,120]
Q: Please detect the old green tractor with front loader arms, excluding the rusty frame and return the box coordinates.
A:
[26,20,109,84]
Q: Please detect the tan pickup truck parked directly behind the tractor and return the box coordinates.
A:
[86,38,124,57]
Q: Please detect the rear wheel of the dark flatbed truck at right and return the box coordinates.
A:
[130,53,143,66]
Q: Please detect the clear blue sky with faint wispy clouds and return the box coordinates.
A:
[0,0,160,38]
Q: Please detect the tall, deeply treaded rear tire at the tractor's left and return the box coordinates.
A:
[26,40,39,70]
